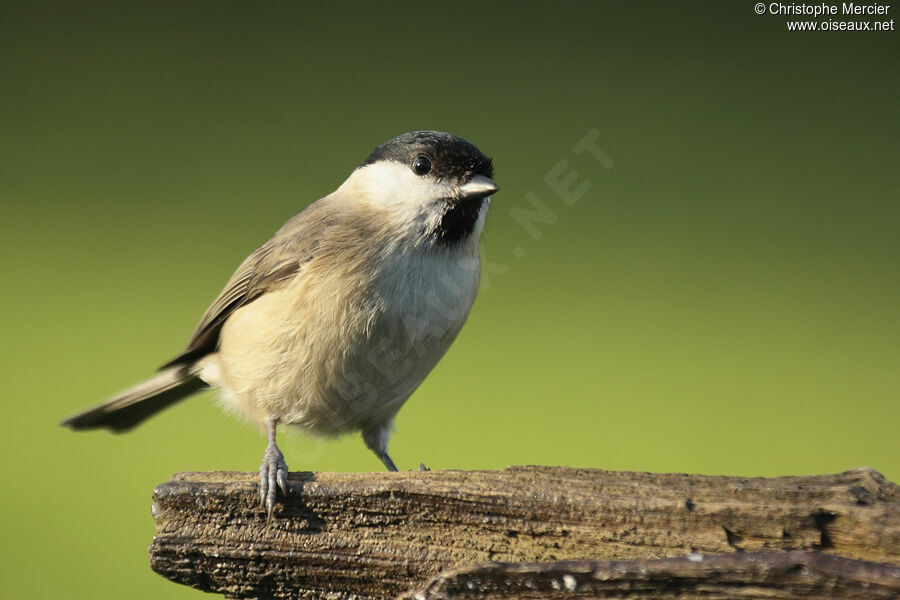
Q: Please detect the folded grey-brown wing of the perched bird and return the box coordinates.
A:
[160,199,333,369]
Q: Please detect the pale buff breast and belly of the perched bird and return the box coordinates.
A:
[219,244,480,434]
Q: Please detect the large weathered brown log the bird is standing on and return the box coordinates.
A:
[150,467,900,598]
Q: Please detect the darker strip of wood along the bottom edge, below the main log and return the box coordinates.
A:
[401,552,900,600]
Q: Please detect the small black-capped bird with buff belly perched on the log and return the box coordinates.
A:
[62,130,498,520]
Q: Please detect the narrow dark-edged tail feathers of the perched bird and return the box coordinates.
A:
[62,366,208,433]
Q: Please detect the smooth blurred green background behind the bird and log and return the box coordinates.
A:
[0,1,900,599]
